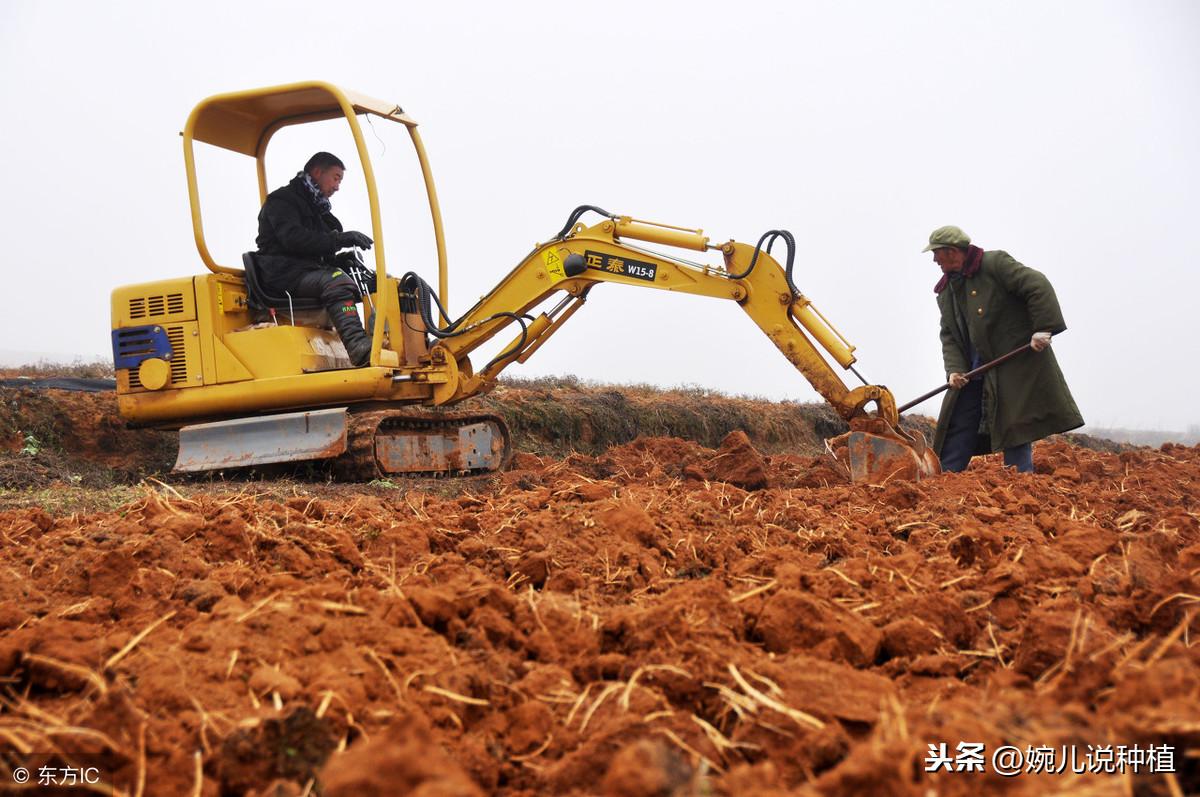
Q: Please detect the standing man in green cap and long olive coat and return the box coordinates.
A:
[923,227,1084,473]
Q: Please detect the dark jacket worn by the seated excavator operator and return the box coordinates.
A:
[256,174,342,289]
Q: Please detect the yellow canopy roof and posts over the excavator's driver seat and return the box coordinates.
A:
[182,80,448,305]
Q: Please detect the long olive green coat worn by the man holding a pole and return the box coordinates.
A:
[934,251,1084,455]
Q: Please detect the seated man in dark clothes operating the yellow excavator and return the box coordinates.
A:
[257,152,372,366]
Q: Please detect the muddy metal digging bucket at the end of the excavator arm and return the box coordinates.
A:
[826,418,942,485]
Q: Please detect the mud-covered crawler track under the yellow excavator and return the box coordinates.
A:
[332,409,512,481]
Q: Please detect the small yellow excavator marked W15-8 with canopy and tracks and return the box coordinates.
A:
[112,82,940,484]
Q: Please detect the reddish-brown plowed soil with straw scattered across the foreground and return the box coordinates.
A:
[0,384,1200,797]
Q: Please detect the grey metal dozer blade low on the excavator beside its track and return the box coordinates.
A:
[175,407,346,472]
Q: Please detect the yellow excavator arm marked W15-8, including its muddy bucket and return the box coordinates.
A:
[401,206,940,483]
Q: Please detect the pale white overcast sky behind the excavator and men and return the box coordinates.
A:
[0,0,1200,430]
